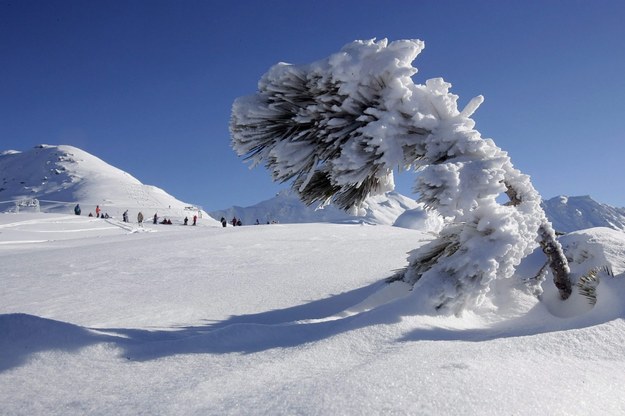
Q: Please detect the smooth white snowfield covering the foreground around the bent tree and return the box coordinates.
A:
[0,213,625,415]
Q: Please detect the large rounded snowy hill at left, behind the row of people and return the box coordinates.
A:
[0,145,217,225]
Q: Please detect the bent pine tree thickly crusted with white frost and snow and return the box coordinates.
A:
[230,39,571,312]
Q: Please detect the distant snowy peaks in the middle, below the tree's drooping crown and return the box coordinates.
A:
[210,189,440,230]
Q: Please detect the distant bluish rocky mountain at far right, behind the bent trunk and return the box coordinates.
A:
[542,196,625,233]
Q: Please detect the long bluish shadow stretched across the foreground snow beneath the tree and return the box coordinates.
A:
[0,282,623,372]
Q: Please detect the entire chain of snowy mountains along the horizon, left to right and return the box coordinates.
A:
[0,144,625,233]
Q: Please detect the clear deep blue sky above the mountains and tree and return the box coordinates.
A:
[0,0,625,210]
